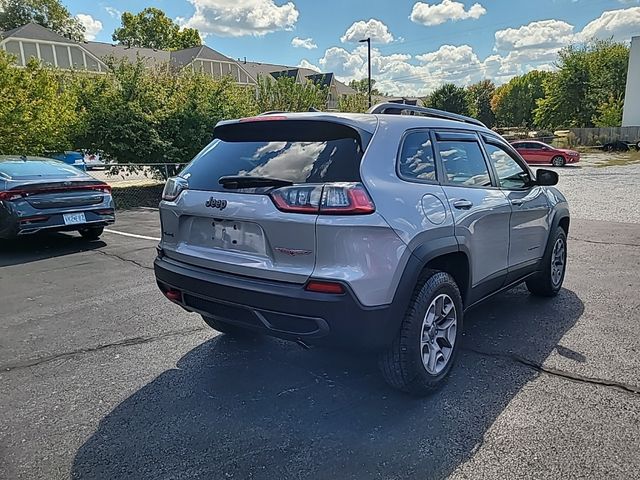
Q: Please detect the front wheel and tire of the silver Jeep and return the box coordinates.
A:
[526,227,567,297]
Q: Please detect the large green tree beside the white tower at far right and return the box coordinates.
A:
[536,40,629,128]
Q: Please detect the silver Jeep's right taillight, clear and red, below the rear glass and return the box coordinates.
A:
[270,183,376,215]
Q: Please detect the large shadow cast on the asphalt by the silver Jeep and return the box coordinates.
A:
[72,288,584,479]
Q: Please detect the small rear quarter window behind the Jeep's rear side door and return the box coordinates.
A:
[398,131,436,182]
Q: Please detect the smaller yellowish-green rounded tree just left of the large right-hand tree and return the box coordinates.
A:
[491,70,552,128]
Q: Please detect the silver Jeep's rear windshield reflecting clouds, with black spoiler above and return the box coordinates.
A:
[180,121,370,191]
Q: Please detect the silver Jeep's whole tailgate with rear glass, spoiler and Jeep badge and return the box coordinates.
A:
[161,117,369,283]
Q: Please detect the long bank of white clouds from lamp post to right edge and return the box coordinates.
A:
[318,7,640,96]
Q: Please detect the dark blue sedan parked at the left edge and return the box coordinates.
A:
[0,155,115,240]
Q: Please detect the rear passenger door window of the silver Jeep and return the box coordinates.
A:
[438,140,491,187]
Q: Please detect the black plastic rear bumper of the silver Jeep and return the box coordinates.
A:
[154,256,402,350]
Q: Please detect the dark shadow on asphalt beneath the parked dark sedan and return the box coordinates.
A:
[0,233,106,267]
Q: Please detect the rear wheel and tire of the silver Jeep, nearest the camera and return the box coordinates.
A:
[379,270,463,396]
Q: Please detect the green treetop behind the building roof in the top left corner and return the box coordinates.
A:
[0,0,85,41]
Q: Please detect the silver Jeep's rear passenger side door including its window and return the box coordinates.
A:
[436,131,511,301]
